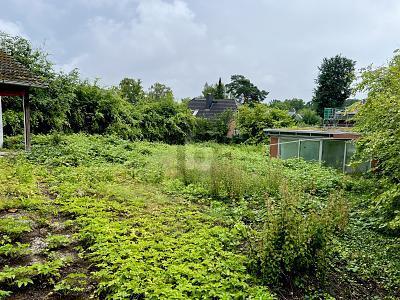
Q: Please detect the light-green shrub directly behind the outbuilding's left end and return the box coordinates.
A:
[237,104,294,143]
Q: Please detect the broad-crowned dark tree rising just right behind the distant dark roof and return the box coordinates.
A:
[226,75,269,104]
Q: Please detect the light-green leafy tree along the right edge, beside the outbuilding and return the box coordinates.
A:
[356,51,400,234]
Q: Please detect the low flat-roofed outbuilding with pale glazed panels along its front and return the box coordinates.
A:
[265,129,371,173]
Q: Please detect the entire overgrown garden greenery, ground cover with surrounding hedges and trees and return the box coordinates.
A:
[0,33,400,299]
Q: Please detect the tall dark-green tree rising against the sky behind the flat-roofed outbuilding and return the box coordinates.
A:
[312,55,356,116]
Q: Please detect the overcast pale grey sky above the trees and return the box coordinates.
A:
[0,0,400,101]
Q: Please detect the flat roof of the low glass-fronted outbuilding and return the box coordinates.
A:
[264,128,360,140]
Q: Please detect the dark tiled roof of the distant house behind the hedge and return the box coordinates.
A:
[188,98,239,119]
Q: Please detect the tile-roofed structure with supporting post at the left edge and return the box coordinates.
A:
[0,50,45,150]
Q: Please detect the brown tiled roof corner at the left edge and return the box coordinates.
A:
[0,50,44,87]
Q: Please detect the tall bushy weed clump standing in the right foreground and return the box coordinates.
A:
[250,189,347,285]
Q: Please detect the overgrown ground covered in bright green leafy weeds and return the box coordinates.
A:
[0,135,400,299]
